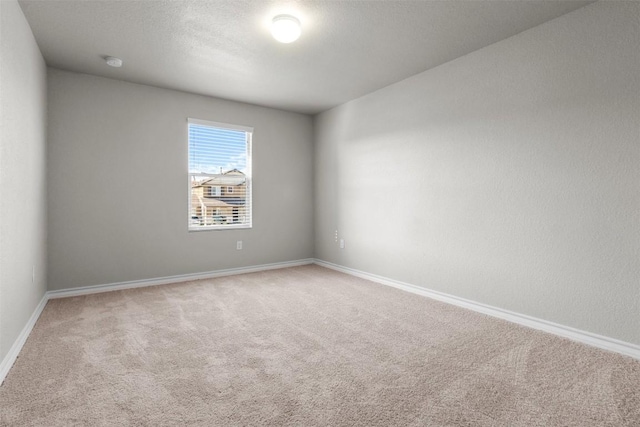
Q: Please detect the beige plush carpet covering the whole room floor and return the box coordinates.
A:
[0,266,640,427]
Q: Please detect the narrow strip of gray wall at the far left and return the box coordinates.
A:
[0,1,47,361]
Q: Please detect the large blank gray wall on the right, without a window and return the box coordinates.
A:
[315,2,640,344]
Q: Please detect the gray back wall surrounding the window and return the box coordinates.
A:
[48,69,313,290]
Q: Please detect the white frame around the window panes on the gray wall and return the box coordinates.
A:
[186,118,253,232]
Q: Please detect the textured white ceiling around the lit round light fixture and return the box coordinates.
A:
[20,0,590,113]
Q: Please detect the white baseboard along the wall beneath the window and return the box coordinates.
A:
[47,258,314,299]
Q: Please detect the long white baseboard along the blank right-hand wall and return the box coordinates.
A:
[315,259,640,359]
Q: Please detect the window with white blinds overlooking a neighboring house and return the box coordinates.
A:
[188,119,253,231]
